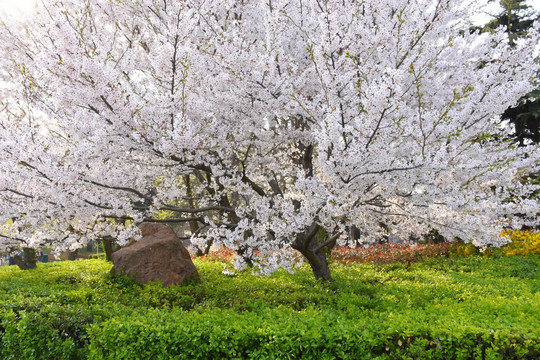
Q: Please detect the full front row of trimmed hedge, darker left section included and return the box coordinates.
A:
[0,307,540,360]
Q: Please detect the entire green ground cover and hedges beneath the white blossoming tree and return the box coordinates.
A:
[0,255,540,359]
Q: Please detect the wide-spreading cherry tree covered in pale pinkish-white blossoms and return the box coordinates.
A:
[0,0,539,280]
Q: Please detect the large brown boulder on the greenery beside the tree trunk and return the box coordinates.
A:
[111,223,199,286]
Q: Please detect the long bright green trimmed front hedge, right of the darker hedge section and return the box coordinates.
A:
[90,308,540,359]
